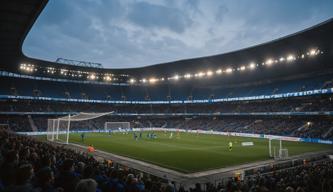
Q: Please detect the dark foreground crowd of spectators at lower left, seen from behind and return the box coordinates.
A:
[0,127,173,192]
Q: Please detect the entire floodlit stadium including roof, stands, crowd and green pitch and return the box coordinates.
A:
[0,0,333,192]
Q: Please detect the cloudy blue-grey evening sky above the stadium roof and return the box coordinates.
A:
[23,0,333,68]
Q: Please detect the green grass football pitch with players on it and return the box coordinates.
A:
[63,132,332,173]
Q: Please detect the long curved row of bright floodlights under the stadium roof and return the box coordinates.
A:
[20,49,323,84]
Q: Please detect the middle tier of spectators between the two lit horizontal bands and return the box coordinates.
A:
[0,95,333,113]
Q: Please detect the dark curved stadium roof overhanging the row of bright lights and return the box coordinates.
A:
[0,0,333,82]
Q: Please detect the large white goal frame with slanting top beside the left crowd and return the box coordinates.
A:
[46,112,113,144]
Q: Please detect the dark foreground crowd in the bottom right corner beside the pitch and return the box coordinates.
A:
[214,160,333,192]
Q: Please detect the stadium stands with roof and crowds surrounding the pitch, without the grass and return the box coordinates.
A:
[0,0,333,192]
